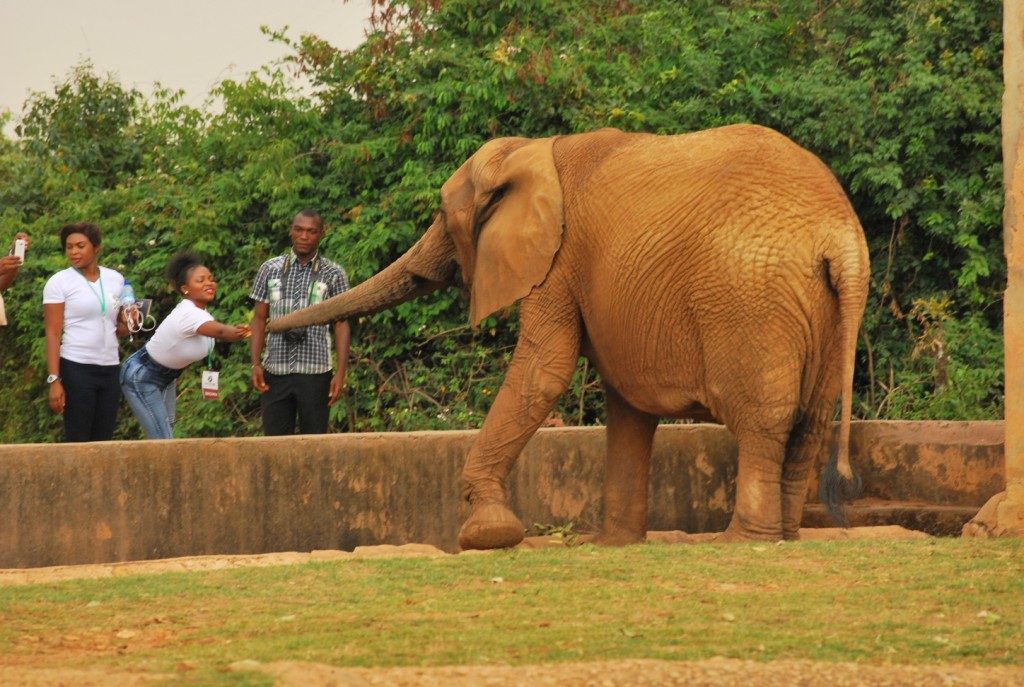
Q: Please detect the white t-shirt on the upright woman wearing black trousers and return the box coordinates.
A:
[43,267,125,364]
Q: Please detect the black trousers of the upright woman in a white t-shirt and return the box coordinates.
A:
[60,358,121,441]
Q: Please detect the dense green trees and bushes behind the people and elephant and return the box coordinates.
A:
[0,0,1006,441]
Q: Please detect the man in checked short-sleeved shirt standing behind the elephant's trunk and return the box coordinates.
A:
[249,210,350,436]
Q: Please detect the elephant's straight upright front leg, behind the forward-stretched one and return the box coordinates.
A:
[594,384,657,546]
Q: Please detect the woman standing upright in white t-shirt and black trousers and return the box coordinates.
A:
[43,222,128,441]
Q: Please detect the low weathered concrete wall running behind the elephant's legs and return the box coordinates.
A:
[0,423,1005,567]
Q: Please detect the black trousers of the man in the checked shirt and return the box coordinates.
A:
[260,372,331,436]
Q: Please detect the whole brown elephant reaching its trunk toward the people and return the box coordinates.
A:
[269,124,869,549]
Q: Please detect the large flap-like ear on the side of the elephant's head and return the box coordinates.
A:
[469,138,563,328]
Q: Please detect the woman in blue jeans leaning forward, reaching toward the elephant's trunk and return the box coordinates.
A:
[121,253,249,439]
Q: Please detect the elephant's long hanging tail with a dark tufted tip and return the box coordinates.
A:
[819,217,870,526]
